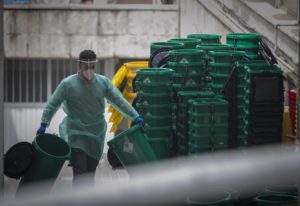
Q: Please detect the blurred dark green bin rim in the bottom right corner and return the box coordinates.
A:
[255,194,298,206]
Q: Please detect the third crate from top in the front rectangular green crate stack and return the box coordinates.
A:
[188,122,228,137]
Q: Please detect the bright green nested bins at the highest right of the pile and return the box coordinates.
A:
[226,33,261,60]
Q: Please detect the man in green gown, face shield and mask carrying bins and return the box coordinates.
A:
[37,50,144,188]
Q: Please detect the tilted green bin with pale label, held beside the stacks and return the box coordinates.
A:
[107,125,157,167]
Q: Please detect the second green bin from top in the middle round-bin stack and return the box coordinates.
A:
[168,61,206,74]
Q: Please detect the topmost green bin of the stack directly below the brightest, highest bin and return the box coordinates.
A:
[208,51,246,65]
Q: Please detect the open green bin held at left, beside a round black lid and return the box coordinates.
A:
[18,134,71,192]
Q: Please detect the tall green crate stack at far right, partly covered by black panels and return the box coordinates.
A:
[235,60,282,147]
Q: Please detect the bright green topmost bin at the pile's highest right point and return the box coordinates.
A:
[226,33,261,47]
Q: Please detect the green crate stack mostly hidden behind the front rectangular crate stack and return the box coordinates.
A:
[175,91,214,155]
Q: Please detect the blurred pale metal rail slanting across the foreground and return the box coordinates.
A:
[1,145,300,206]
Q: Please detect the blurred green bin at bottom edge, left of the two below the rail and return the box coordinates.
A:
[186,190,234,206]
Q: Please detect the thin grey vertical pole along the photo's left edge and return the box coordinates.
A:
[0,1,4,196]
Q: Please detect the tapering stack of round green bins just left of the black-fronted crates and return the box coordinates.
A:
[208,51,245,94]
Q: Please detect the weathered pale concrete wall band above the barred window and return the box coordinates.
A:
[4,5,178,58]
